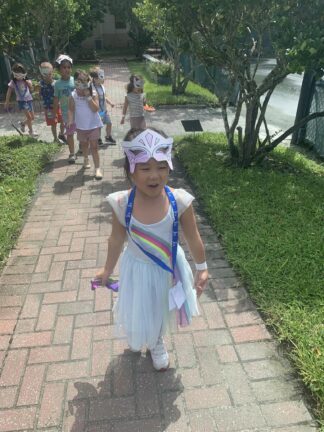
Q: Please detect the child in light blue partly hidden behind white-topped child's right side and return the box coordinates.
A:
[90,68,116,145]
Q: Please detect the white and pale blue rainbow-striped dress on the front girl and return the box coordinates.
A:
[107,189,199,350]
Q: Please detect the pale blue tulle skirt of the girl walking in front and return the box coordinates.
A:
[114,246,199,350]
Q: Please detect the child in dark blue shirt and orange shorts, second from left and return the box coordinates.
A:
[39,61,65,142]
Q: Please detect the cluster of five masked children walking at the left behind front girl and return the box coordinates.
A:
[5,54,116,180]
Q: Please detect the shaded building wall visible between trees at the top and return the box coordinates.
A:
[82,13,131,49]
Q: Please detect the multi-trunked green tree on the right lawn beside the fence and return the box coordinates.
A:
[158,0,324,166]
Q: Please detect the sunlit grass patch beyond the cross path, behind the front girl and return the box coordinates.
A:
[127,61,217,106]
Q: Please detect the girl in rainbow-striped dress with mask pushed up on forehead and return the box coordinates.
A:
[97,129,208,371]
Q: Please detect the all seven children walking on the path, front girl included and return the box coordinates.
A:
[6,54,208,371]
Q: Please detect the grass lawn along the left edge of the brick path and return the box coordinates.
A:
[0,137,59,270]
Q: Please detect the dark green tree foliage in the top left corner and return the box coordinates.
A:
[0,0,107,61]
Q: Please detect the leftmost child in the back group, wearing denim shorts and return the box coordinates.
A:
[4,63,38,137]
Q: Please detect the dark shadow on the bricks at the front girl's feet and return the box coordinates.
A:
[67,350,183,432]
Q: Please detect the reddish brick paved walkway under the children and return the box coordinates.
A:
[0,62,315,432]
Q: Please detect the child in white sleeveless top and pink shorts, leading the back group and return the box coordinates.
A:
[68,70,103,180]
